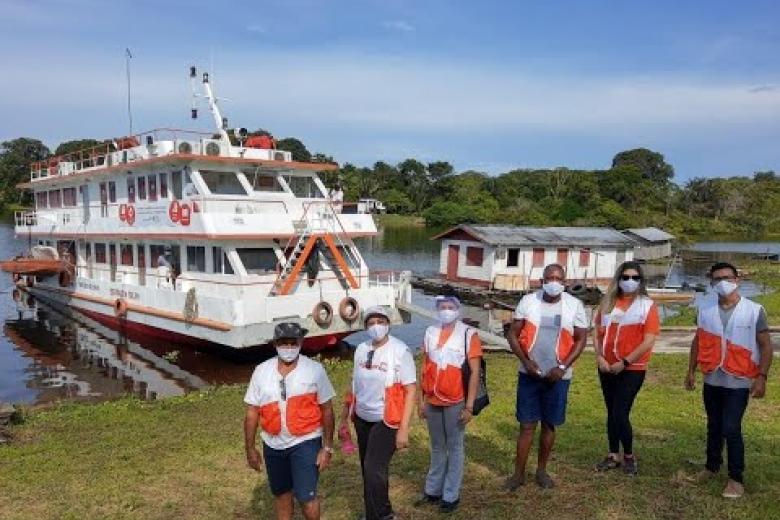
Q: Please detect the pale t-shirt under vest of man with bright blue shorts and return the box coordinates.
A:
[515,295,588,379]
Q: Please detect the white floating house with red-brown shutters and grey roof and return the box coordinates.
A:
[433,224,635,291]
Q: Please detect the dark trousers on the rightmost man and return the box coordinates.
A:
[702,383,750,483]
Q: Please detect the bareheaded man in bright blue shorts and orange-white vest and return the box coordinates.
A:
[506,264,588,491]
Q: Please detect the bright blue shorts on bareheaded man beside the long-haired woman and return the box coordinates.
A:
[515,372,571,426]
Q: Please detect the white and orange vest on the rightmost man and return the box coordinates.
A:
[696,297,761,379]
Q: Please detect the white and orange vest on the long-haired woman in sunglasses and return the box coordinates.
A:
[601,295,653,369]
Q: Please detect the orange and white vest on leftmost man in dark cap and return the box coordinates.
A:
[257,356,322,436]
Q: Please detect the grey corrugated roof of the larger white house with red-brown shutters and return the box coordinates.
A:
[437,224,634,247]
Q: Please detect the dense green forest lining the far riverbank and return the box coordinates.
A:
[0,135,780,238]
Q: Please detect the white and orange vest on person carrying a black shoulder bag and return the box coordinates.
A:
[422,320,476,404]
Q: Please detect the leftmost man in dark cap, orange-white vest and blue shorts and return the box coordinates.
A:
[244,323,335,520]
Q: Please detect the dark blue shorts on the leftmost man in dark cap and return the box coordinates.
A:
[263,437,322,504]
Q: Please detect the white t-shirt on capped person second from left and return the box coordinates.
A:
[352,336,417,422]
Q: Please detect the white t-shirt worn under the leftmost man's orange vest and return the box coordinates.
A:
[244,356,336,450]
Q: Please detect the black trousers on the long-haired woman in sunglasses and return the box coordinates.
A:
[599,370,645,455]
